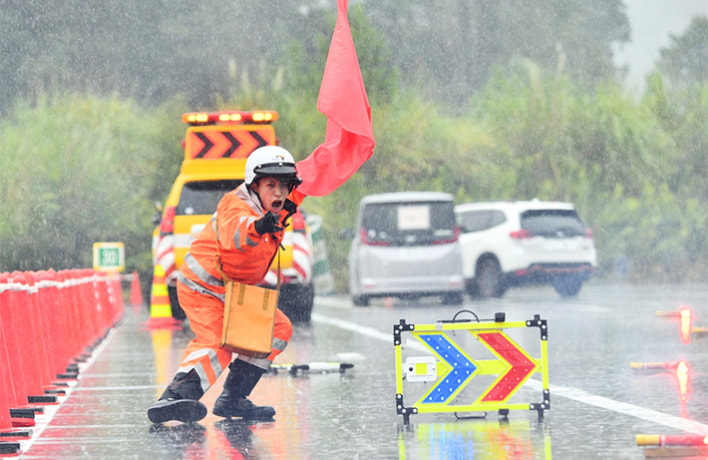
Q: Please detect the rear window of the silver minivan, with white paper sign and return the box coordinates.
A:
[362,201,455,246]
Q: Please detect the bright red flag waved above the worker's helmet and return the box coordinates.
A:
[297,0,376,196]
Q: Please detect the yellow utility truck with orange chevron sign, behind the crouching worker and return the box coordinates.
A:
[153,111,314,321]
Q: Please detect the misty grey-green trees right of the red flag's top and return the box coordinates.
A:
[365,0,630,107]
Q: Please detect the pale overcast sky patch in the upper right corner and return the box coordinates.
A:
[615,0,708,92]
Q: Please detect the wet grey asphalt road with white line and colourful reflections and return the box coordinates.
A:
[12,283,708,459]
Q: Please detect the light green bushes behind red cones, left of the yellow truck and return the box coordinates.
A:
[0,95,180,270]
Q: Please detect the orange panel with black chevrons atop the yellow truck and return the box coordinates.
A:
[185,127,275,160]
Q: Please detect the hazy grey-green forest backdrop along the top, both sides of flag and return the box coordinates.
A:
[0,0,629,113]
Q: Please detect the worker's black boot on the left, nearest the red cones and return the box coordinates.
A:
[148,370,207,423]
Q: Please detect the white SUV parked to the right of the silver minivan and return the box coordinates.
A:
[455,200,597,297]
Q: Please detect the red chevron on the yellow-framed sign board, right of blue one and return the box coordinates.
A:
[477,332,536,402]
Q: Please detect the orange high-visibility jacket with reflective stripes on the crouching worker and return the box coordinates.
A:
[179,184,305,300]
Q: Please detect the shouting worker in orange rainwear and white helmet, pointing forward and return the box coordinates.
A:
[148,146,305,423]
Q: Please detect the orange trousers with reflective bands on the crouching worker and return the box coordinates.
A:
[177,282,293,393]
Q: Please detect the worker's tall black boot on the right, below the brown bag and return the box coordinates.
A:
[212,359,275,420]
